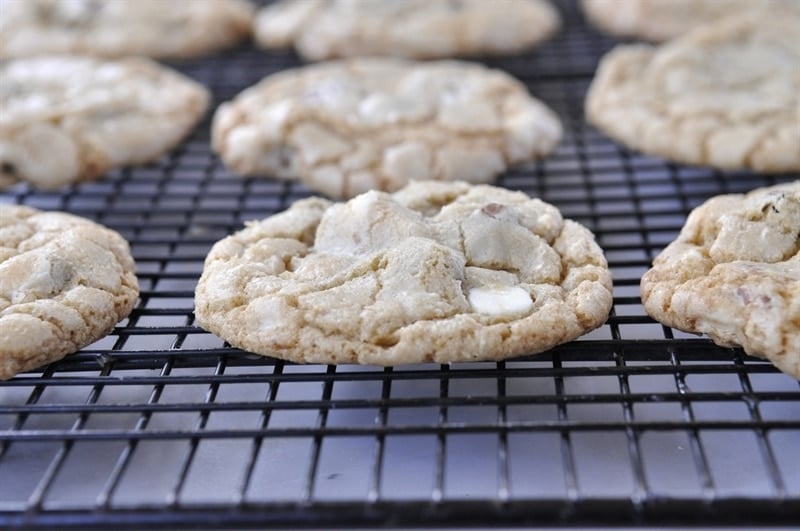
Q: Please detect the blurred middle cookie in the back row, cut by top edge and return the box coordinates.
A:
[254,0,561,61]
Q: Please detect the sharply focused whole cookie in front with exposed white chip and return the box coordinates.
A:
[195,181,612,366]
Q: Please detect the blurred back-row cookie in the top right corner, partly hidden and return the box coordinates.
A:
[581,0,800,42]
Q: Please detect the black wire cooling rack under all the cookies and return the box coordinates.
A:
[0,2,800,527]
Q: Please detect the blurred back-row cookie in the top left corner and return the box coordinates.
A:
[0,0,255,58]
